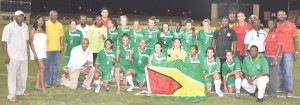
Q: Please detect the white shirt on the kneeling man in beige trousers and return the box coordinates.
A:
[68,45,93,69]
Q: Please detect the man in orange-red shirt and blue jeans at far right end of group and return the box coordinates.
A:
[277,10,298,98]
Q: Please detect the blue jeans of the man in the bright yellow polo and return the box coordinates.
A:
[45,51,60,84]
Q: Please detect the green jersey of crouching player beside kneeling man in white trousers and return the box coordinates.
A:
[222,56,241,76]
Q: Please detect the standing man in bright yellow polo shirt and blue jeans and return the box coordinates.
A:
[45,10,64,88]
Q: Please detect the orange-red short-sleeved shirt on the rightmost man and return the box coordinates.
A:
[277,20,298,52]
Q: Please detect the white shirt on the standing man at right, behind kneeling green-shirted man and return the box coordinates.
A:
[244,29,268,52]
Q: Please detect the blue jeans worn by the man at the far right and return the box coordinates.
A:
[278,52,294,93]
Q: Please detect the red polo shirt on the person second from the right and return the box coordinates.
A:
[265,29,285,57]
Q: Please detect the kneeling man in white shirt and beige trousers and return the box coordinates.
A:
[60,38,95,90]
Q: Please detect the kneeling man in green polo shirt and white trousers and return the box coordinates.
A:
[242,45,269,102]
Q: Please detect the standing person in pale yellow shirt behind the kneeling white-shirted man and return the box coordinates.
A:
[87,16,107,63]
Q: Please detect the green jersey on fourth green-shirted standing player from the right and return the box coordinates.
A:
[159,30,173,49]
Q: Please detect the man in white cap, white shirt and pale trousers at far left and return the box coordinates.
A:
[2,10,29,102]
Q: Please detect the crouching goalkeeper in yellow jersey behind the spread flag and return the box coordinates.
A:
[167,38,187,62]
